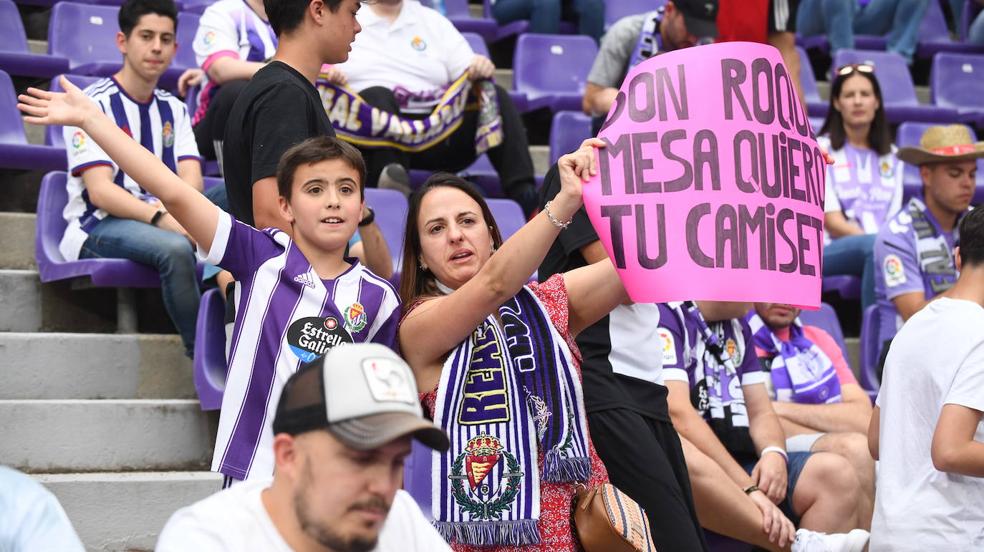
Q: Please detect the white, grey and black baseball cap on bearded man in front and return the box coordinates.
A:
[273,343,449,452]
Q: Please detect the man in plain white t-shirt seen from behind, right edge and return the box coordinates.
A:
[868,209,984,552]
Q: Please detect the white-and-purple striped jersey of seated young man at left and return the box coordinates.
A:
[59,77,201,261]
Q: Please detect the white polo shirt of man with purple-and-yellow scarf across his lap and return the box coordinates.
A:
[335,1,474,112]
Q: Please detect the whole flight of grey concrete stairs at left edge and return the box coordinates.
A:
[0,212,221,551]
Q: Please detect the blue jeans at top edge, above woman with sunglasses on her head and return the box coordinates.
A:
[796,0,935,63]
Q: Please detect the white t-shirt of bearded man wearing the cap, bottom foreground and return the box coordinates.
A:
[155,480,450,552]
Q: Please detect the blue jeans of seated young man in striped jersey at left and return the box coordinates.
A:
[79,216,201,357]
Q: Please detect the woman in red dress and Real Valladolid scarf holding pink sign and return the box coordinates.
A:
[399,139,627,552]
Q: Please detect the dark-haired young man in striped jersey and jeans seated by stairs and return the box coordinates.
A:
[59,0,202,356]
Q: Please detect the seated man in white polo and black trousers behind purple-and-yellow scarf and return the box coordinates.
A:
[328,0,536,216]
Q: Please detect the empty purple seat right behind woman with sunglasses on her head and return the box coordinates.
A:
[831,50,958,123]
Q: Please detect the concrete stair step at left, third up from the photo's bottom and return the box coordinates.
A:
[0,333,196,400]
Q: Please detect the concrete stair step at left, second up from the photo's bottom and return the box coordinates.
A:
[0,398,217,473]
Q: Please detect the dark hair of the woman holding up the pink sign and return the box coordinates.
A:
[400,173,502,308]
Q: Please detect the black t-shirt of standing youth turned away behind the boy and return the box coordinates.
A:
[222,61,335,226]
